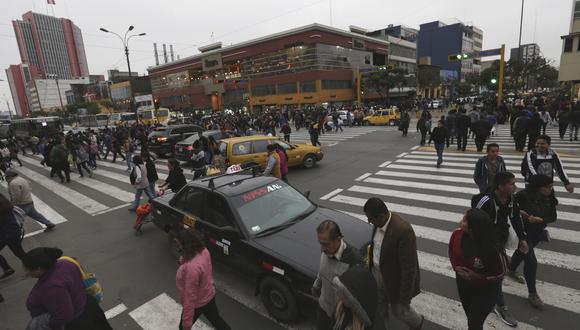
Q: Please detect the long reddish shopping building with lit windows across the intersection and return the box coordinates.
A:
[148,24,389,111]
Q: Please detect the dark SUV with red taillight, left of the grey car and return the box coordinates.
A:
[147,125,203,157]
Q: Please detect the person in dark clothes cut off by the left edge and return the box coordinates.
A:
[0,194,26,280]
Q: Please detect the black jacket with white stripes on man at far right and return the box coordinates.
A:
[522,149,570,185]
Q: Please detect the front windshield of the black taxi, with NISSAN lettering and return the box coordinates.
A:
[233,182,314,235]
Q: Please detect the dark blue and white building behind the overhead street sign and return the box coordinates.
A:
[417,21,483,79]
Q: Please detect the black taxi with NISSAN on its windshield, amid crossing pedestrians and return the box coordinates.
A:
[153,173,371,323]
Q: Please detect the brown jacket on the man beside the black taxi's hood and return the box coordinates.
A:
[368,212,421,305]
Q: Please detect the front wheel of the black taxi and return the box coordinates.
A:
[260,277,298,323]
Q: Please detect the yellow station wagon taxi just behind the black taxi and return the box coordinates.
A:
[219,135,323,168]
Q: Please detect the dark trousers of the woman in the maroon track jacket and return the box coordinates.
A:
[456,275,501,330]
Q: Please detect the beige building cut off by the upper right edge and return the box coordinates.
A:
[558,0,580,100]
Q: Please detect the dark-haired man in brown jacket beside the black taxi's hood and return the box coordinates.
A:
[364,197,424,329]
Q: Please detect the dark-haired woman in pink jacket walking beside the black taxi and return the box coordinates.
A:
[176,230,230,330]
